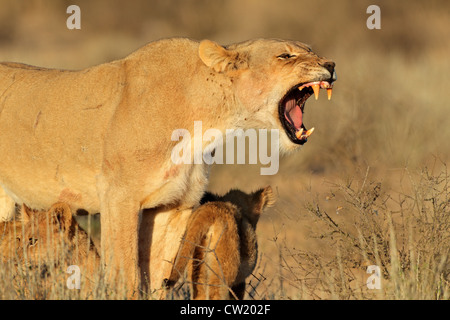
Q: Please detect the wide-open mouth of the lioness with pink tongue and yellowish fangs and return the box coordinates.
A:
[278,81,333,145]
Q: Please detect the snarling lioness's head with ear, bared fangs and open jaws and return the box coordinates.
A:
[199,39,337,151]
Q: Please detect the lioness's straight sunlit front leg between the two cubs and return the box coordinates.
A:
[100,182,140,298]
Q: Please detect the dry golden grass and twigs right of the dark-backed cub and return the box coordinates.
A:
[217,165,450,300]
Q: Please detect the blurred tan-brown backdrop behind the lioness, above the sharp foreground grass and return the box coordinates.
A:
[0,0,450,298]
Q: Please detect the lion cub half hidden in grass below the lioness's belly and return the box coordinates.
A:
[0,203,101,294]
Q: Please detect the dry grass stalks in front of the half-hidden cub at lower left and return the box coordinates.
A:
[0,212,126,300]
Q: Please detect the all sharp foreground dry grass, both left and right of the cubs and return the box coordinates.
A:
[0,165,450,299]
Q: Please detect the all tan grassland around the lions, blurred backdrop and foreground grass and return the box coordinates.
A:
[0,0,450,299]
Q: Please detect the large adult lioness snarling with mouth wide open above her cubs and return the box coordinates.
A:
[0,39,336,292]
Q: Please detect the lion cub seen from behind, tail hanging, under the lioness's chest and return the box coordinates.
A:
[165,187,275,300]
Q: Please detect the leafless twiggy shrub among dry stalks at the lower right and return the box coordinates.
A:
[281,165,450,299]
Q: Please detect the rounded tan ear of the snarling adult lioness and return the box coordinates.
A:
[198,40,243,72]
